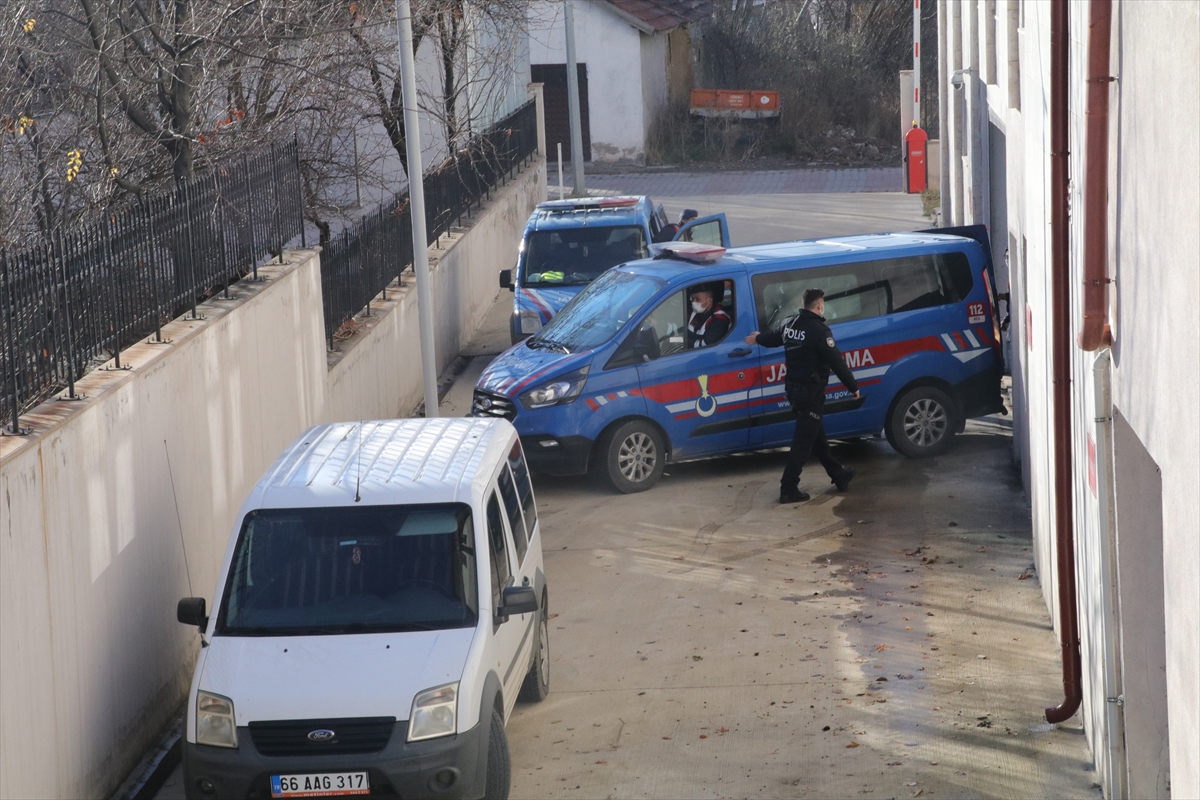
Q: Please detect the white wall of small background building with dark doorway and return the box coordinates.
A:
[529,0,652,162]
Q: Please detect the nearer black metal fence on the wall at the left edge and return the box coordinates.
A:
[0,142,304,432]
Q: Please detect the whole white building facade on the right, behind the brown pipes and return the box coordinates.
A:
[938,0,1200,798]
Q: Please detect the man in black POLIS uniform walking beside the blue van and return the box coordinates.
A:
[745,289,859,503]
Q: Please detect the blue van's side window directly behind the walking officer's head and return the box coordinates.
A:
[751,264,887,331]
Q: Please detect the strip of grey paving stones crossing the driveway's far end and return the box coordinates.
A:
[580,167,904,197]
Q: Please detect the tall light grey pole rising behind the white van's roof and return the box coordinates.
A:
[396,0,438,417]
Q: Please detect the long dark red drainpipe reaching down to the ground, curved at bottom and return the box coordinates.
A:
[1045,0,1082,723]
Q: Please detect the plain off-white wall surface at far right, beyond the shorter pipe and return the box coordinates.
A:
[1109,1,1200,798]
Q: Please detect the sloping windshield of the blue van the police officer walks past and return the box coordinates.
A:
[526,270,666,353]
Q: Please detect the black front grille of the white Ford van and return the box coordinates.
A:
[250,717,396,756]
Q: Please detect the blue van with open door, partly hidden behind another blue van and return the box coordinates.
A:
[500,196,730,344]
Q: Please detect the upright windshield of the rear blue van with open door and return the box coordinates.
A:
[521,225,649,287]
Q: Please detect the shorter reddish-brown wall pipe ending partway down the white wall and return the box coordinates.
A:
[1079,0,1114,350]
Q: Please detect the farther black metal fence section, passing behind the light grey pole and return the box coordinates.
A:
[320,101,538,348]
